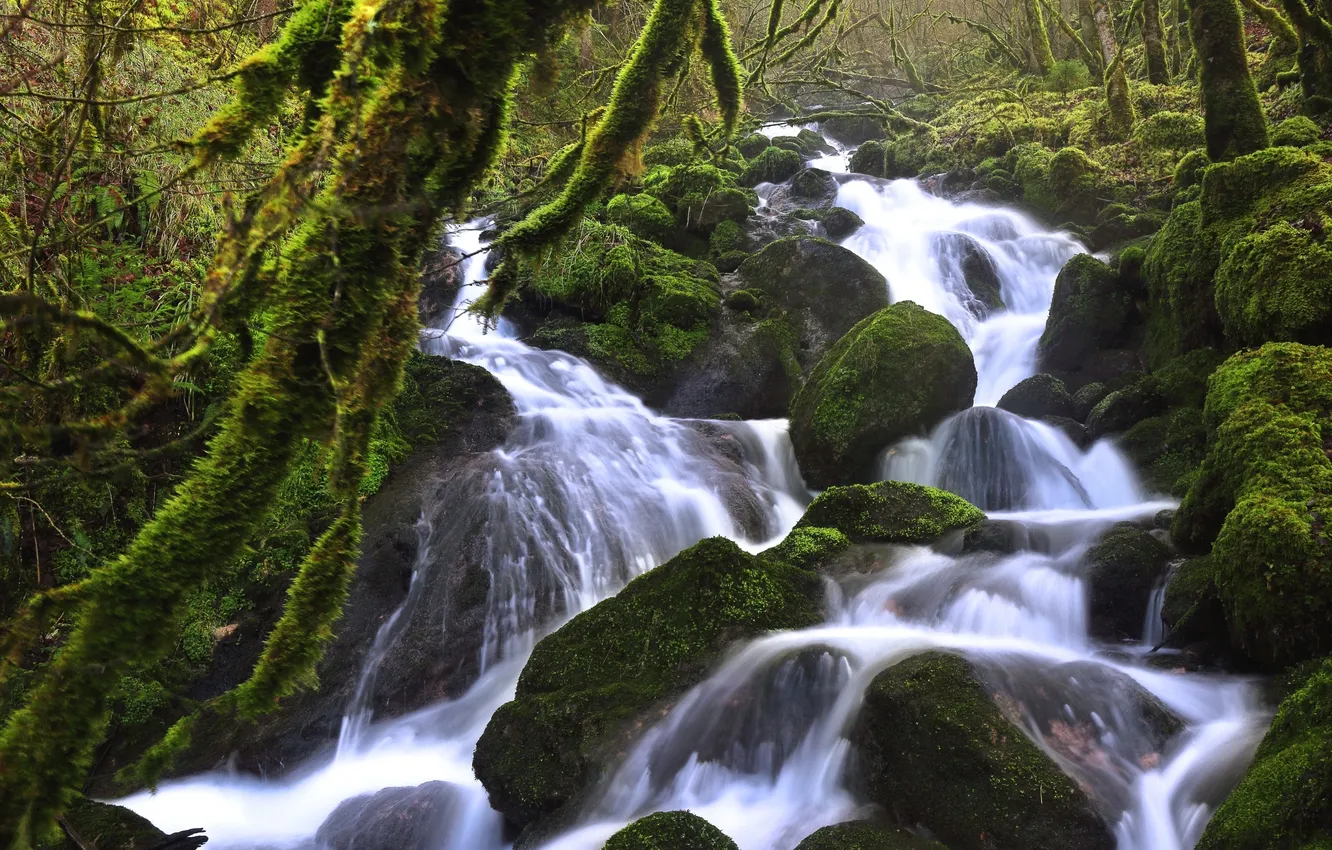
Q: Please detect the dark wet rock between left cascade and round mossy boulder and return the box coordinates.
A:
[663,313,803,420]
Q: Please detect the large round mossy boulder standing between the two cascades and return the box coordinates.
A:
[791,301,976,489]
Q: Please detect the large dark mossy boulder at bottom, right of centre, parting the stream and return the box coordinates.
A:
[851,651,1114,850]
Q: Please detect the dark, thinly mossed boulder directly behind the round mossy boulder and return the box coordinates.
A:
[739,236,888,369]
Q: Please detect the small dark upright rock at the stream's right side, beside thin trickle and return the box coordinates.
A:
[1084,522,1171,641]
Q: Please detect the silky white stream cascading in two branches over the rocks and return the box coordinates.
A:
[124,133,1269,850]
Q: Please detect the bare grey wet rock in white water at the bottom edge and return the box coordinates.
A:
[314,782,458,850]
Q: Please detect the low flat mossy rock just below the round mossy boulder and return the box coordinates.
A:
[793,481,986,544]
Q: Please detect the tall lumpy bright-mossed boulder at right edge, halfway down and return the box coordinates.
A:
[1172,342,1332,665]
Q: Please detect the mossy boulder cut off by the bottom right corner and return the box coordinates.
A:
[1197,659,1332,850]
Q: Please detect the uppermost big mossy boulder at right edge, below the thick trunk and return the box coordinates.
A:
[1143,148,1332,365]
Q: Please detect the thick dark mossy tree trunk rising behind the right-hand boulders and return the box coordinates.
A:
[1189,0,1268,163]
